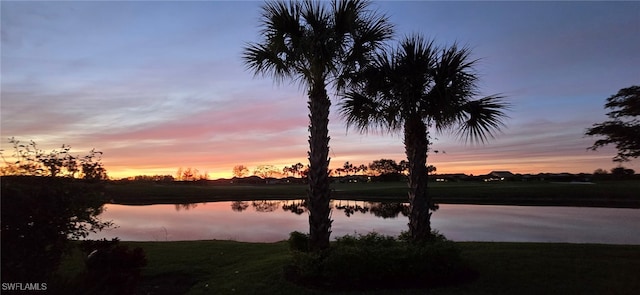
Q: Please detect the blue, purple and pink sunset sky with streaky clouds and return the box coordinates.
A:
[0,1,640,178]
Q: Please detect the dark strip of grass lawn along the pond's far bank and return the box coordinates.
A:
[106,181,640,208]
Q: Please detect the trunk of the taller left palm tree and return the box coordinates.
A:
[307,83,332,251]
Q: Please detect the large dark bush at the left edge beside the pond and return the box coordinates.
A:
[0,176,111,282]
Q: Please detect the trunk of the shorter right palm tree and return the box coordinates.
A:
[404,118,431,242]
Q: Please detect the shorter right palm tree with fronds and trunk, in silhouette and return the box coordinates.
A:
[341,35,508,241]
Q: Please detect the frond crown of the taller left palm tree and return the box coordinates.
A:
[243,0,392,90]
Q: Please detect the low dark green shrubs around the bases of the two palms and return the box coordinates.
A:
[286,233,473,290]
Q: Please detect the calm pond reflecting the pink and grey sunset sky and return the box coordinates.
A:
[89,200,640,244]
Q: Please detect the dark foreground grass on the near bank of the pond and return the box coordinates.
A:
[60,241,640,294]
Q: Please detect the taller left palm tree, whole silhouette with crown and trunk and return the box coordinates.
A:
[243,0,392,250]
